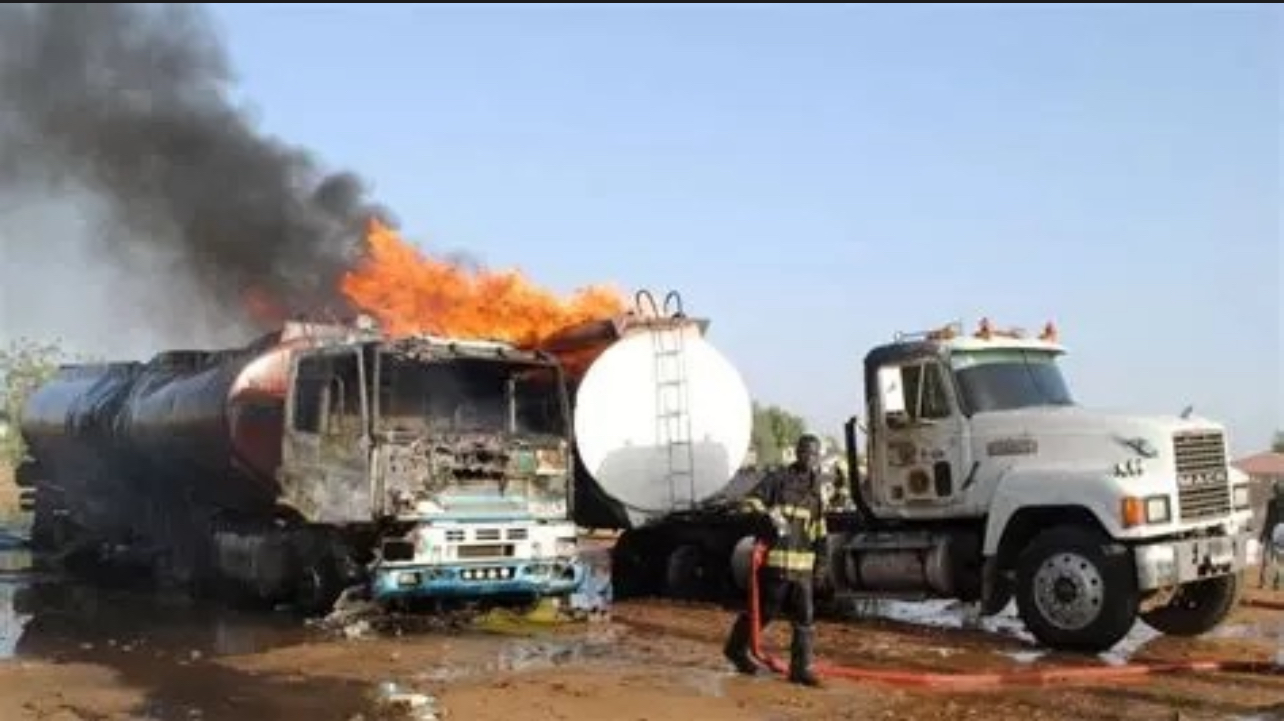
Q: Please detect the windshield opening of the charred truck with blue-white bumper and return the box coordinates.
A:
[379,354,568,436]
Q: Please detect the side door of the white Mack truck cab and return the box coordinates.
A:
[872,358,971,517]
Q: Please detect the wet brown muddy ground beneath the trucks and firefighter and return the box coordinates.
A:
[0,531,1284,721]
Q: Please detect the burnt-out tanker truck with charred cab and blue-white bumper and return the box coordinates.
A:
[19,316,583,613]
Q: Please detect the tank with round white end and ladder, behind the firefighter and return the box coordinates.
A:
[541,297,752,530]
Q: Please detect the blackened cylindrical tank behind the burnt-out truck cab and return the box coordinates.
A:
[21,323,359,535]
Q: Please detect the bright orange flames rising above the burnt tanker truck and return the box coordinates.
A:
[342,215,625,348]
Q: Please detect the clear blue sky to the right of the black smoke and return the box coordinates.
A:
[205,4,1284,453]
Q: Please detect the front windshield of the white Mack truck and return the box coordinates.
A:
[950,349,1075,413]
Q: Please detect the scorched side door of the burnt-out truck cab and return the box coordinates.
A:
[280,348,370,523]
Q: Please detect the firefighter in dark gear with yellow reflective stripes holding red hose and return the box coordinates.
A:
[723,434,826,686]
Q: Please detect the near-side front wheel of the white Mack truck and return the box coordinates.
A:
[1016,526,1140,653]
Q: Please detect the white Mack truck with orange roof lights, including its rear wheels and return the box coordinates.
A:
[615,314,1260,652]
